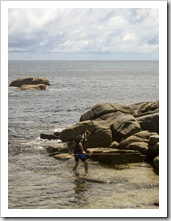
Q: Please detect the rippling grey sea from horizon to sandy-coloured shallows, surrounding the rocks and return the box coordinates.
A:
[8,61,159,209]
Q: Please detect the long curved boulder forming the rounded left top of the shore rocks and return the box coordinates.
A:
[80,103,132,121]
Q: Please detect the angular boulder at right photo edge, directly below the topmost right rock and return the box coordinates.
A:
[136,113,159,133]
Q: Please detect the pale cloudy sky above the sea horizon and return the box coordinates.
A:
[8,8,159,60]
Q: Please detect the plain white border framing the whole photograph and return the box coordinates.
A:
[1,1,167,217]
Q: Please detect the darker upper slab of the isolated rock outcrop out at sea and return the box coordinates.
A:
[9,77,50,87]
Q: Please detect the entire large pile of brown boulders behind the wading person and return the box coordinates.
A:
[40,101,159,171]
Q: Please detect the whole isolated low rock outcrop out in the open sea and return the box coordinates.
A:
[9,77,50,90]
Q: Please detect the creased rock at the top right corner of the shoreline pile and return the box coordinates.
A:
[130,101,159,117]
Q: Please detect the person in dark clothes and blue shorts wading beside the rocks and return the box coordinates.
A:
[73,130,90,173]
